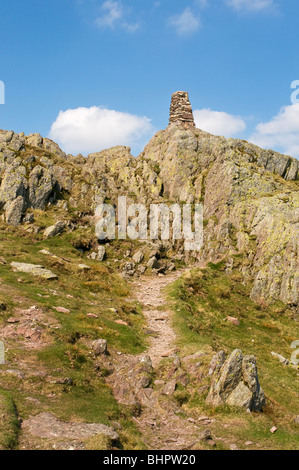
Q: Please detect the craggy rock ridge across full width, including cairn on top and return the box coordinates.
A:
[0,92,299,308]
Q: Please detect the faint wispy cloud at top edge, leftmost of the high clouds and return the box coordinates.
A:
[95,0,139,33]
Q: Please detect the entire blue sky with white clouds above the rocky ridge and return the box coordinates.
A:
[0,0,299,157]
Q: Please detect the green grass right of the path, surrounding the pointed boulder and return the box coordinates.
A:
[169,263,299,449]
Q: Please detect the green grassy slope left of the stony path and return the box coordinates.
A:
[0,222,146,448]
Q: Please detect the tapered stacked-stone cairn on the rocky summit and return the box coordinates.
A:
[169,91,195,129]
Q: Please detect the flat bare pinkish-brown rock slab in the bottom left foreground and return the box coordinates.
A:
[22,413,119,441]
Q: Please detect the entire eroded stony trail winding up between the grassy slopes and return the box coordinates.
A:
[109,272,214,450]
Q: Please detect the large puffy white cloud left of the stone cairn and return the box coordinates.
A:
[49,106,153,155]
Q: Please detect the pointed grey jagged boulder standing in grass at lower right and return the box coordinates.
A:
[207,349,266,411]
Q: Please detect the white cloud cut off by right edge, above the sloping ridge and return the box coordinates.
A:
[249,103,299,157]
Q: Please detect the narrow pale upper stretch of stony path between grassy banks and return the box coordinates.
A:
[134,272,182,367]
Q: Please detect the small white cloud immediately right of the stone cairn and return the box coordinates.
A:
[194,109,246,137]
